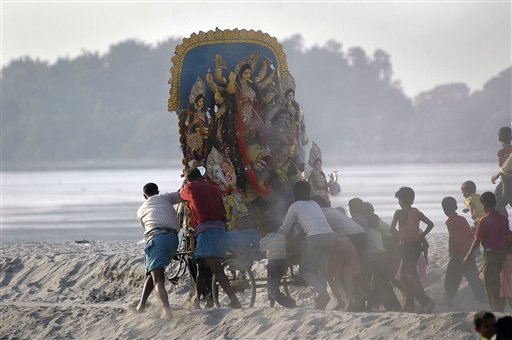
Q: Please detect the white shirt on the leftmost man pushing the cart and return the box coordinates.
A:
[137,192,182,239]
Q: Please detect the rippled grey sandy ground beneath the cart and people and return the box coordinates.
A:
[0,234,508,339]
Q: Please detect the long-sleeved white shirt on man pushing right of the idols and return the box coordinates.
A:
[277,201,332,237]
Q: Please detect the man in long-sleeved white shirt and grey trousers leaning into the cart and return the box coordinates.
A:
[278,181,335,309]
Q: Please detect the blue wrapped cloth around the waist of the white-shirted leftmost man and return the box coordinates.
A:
[144,233,178,275]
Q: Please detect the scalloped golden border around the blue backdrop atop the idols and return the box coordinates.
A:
[167,29,288,112]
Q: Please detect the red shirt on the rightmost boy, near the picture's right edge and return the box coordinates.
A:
[475,211,510,250]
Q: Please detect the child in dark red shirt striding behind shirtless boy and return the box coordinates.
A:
[441,197,484,306]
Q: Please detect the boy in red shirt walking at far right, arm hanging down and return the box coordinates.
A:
[464,192,510,312]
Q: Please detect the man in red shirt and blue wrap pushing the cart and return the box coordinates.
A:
[180,168,241,308]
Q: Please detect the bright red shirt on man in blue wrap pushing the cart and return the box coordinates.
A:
[180,180,226,228]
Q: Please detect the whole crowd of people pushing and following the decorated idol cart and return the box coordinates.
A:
[136,127,512,322]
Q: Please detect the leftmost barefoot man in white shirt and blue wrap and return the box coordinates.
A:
[136,183,181,318]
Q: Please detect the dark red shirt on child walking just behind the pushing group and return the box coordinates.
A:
[446,214,474,258]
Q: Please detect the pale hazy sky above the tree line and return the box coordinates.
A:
[1,0,512,95]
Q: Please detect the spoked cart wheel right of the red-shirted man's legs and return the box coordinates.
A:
[212,260,256,308]
